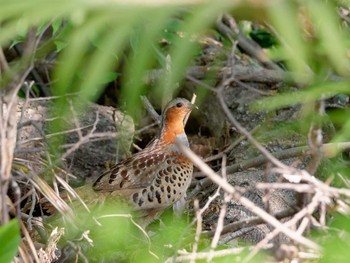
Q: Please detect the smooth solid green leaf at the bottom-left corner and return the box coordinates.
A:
[0,219,20,263]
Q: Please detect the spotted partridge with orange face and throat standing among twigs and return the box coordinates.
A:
[93,98,193,226]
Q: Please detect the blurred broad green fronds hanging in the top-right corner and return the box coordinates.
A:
[268,1,349,83]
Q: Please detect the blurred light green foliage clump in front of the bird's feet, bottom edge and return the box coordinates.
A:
[48,200,194,262]
